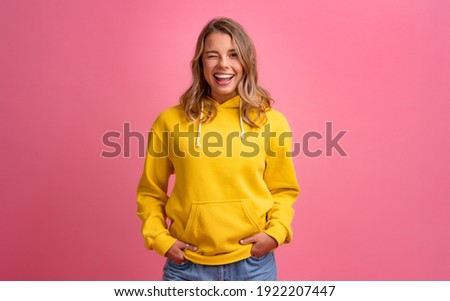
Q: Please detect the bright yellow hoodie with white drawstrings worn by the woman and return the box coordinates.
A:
[137,96,299,265]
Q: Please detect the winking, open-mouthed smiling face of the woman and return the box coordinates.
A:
[202,32,243,103]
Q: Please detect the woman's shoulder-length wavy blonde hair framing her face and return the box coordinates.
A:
[180,18,273,127]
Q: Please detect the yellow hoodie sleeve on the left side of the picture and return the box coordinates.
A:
[137,128,176,256]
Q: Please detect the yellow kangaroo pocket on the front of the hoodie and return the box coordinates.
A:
[185,199,265,256]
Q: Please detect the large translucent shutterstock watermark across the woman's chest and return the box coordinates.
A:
[100,121,348,158]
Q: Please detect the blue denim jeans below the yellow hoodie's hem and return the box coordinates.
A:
[163,252,277,281]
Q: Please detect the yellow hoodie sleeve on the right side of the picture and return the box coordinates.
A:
[264,113,300,245]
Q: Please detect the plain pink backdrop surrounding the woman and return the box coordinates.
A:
[0,0,450,280]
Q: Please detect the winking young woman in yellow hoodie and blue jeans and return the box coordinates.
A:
[137,18,299,281]
